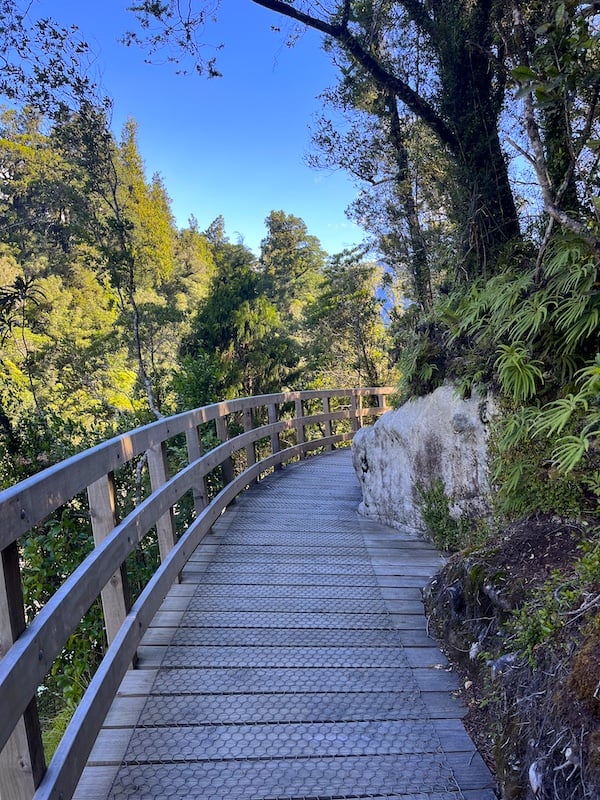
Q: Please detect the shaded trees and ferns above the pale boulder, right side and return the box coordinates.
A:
[123,0,600,496]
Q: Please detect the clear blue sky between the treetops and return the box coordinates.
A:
[39,0,363,253]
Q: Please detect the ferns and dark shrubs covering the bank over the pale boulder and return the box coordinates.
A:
[395,235,600,520]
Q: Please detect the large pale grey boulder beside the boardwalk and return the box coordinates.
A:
[352,386,489,530]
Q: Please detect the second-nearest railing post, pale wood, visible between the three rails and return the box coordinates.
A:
[87,473,128,644]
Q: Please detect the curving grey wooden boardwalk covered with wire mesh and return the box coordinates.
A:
[76,450,494,800]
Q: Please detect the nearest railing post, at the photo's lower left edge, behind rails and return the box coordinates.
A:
[0,542,46,800]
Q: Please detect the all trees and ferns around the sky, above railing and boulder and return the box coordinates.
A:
[0,0,600,520]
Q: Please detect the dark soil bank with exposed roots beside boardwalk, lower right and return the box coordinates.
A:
[426,515,600,800]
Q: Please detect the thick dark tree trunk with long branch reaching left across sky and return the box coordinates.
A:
[253,0,520,278]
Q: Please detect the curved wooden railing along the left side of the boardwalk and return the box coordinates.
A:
[0,388,392,800]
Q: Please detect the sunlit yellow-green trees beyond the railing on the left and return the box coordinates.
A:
[0,101,391,484]
